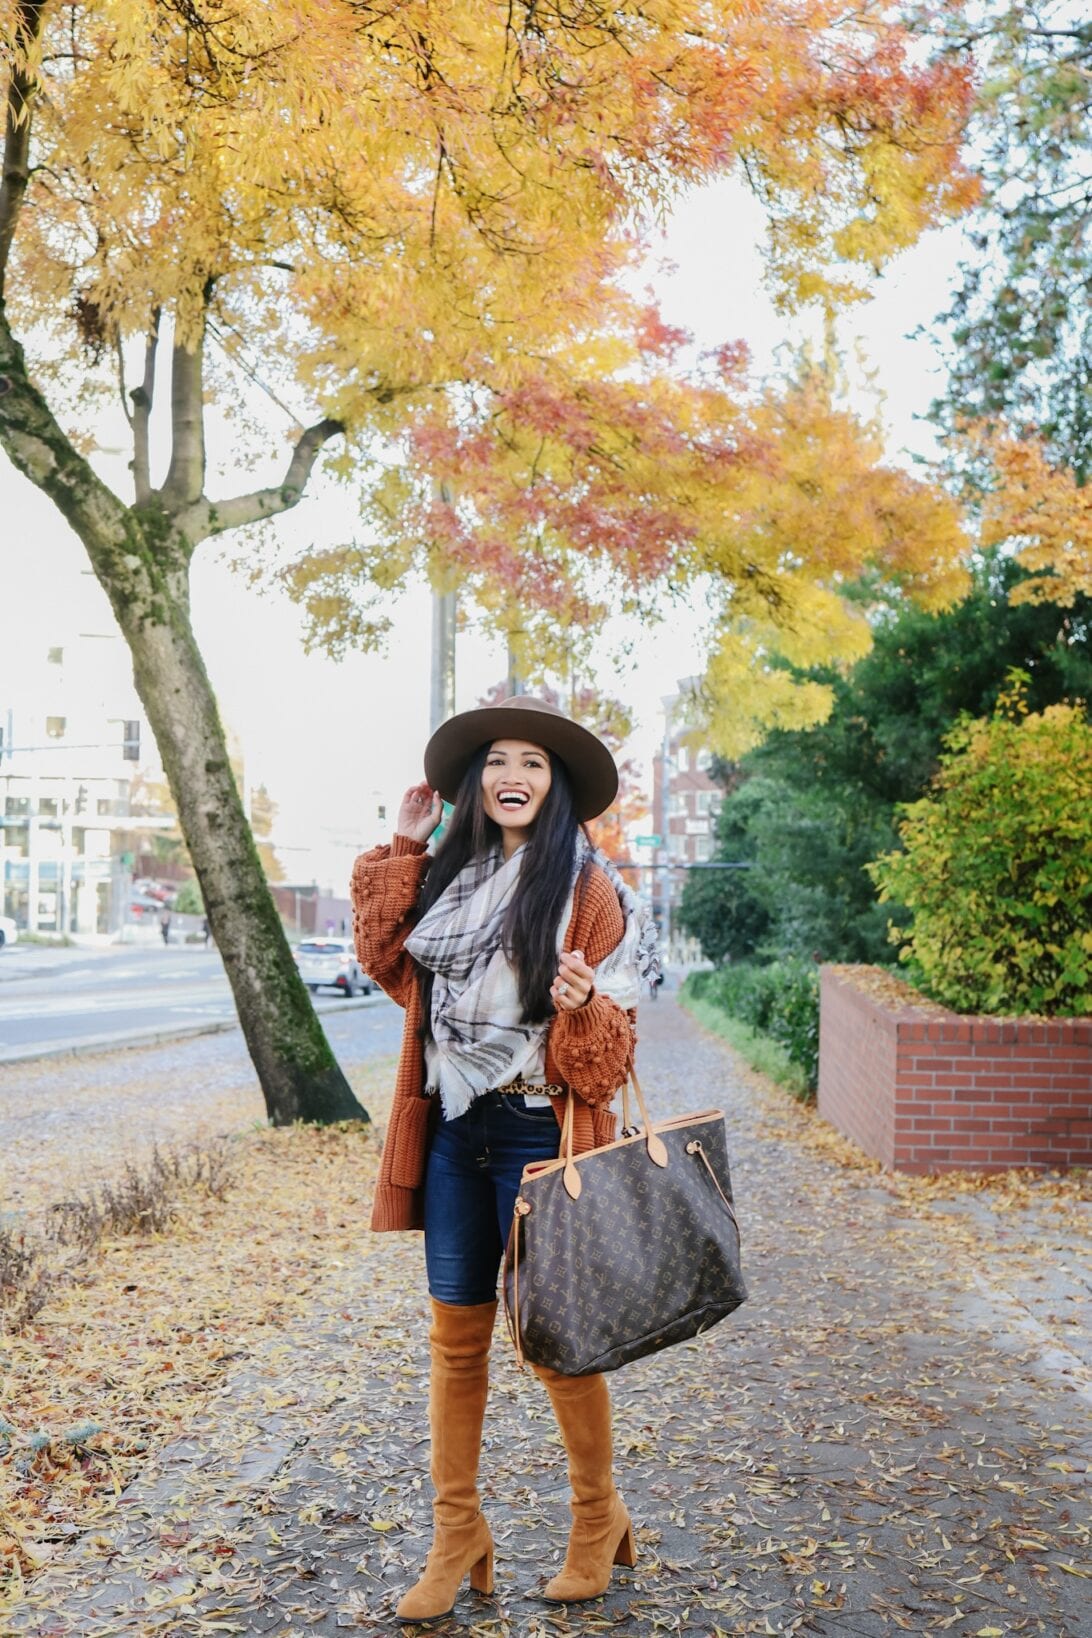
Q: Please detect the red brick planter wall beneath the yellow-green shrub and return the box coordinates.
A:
[819,966,1092,1171]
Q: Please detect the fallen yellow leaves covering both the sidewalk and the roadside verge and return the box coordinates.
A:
[3,998,1092,1638]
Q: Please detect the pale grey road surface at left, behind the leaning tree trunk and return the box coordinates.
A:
[0,945,378,1063]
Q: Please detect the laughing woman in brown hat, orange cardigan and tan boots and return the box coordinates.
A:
[352,696,657,1620]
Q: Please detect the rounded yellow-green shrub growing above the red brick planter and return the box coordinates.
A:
[869,675,1092,1014]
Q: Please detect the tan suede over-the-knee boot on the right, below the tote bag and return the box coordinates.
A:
[534,1364,637,1604]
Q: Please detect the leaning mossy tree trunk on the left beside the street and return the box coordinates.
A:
[0,321,368,1125]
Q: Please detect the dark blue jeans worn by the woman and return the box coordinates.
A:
[424,1093,562,1307]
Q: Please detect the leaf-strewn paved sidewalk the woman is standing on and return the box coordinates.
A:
[11,998,1092,1638]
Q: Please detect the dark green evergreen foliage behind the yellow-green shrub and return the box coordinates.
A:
[681,554,1092,962]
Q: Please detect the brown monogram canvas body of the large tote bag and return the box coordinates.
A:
[504,1114,747,1376]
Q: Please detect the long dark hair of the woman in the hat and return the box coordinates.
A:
[417,745,581,1035]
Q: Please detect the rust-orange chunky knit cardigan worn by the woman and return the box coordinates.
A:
[352,835,637,1229]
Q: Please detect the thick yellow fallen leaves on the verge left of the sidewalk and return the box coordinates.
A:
[0,1061,393,1592]
